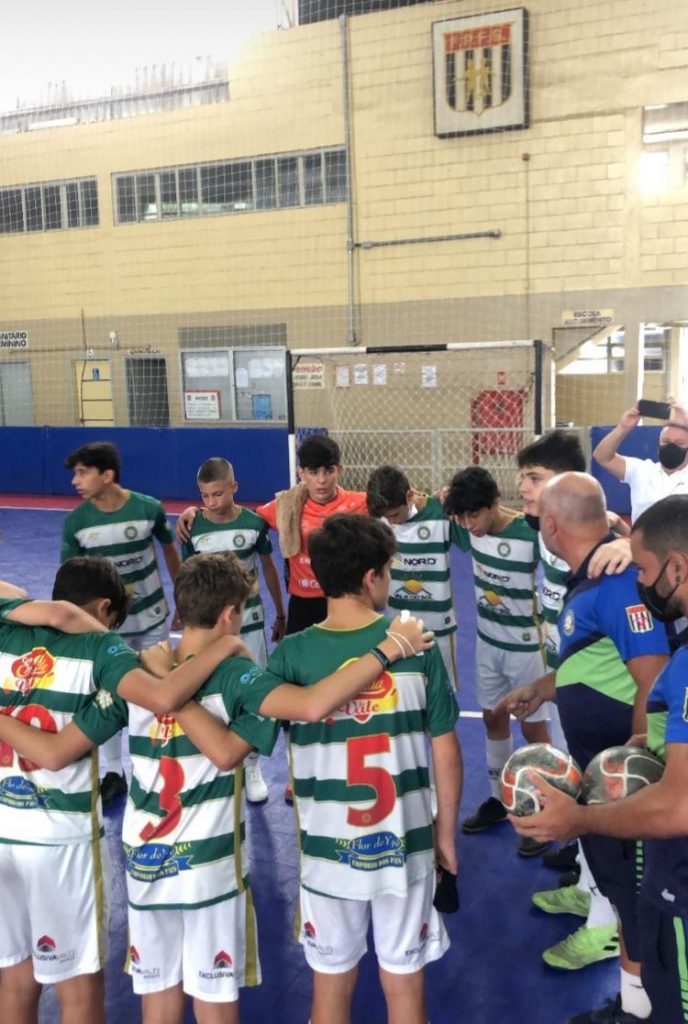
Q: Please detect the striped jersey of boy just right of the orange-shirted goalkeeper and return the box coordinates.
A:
[387,498,459,636]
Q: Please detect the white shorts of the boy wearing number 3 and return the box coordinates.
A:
[126,890,260,1002]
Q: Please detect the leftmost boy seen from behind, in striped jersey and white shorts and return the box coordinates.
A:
[0,557,237,1024]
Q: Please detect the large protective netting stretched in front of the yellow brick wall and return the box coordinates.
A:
[0,0,688,497]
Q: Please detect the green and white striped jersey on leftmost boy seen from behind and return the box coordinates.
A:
[0,601,139,846]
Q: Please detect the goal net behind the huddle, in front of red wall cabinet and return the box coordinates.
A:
[290,341,543,501]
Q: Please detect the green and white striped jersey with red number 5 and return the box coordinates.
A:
[268,616,458,900]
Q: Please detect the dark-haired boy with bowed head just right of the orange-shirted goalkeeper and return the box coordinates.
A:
[367,466,459,690]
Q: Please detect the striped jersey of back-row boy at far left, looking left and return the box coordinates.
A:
[59,490,174,638]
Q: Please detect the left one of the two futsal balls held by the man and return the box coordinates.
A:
[502,743,583,817]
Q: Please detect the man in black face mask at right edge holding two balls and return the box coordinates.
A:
[514,495,688,1024]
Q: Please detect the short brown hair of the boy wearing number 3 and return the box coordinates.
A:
[174,551,256,630]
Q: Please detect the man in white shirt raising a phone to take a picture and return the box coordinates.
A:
[593,398,688,522]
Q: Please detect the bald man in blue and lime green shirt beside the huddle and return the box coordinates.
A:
[501,473,668,1024]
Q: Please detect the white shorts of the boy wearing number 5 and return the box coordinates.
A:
[299,871,449,974]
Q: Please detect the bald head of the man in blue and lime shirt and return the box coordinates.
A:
[540,473,609,565]
